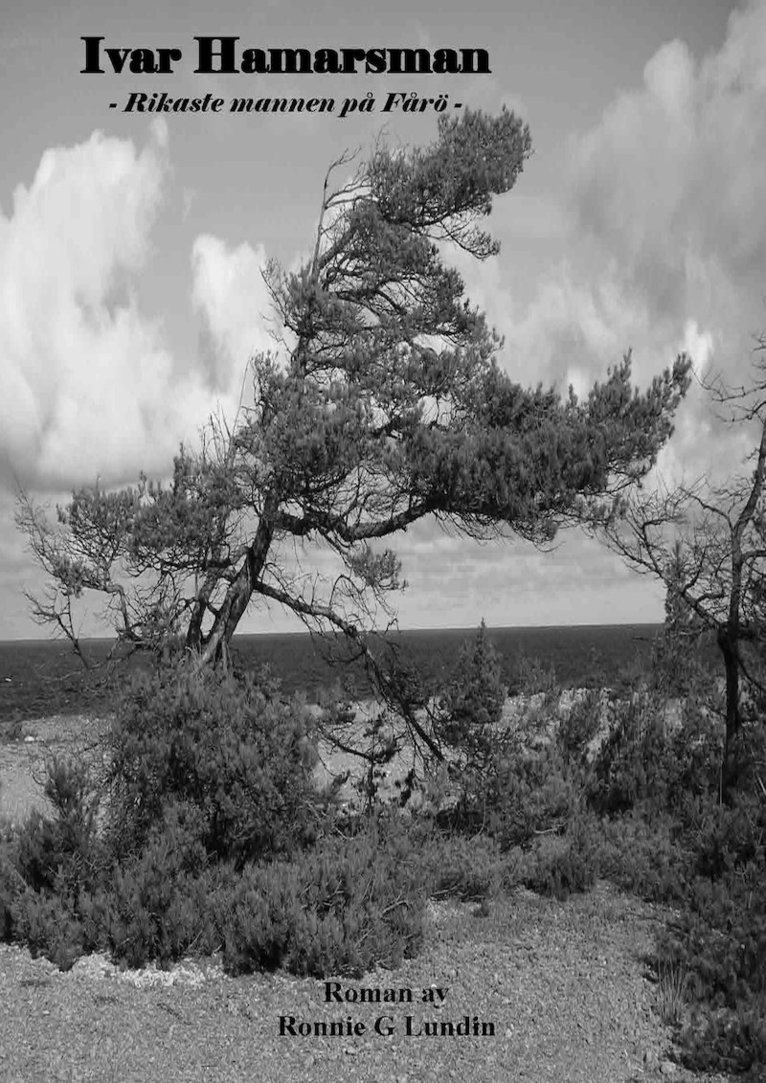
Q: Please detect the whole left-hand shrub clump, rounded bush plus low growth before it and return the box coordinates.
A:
[0,667,427,975]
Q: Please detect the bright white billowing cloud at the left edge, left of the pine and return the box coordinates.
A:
[0,125,212,486]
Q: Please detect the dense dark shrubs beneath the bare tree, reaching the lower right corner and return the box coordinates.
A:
[439,623,766,1080]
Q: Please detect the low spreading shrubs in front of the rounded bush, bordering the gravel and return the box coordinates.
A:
[0,767,428,976]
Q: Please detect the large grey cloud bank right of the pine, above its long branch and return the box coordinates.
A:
[460,0,766,474]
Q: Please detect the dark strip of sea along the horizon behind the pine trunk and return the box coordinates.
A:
[0,624,660,721]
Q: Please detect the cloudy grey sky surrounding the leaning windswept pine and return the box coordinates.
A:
[0,0,766,639]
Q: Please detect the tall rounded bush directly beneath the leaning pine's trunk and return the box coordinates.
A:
[100,665,322,869]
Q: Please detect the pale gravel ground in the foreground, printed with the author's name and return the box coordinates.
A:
[0,884,723,1083]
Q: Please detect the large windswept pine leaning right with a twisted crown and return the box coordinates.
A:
[18,109,688,684]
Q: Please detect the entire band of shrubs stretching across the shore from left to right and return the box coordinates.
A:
[0,626,766,1080]
